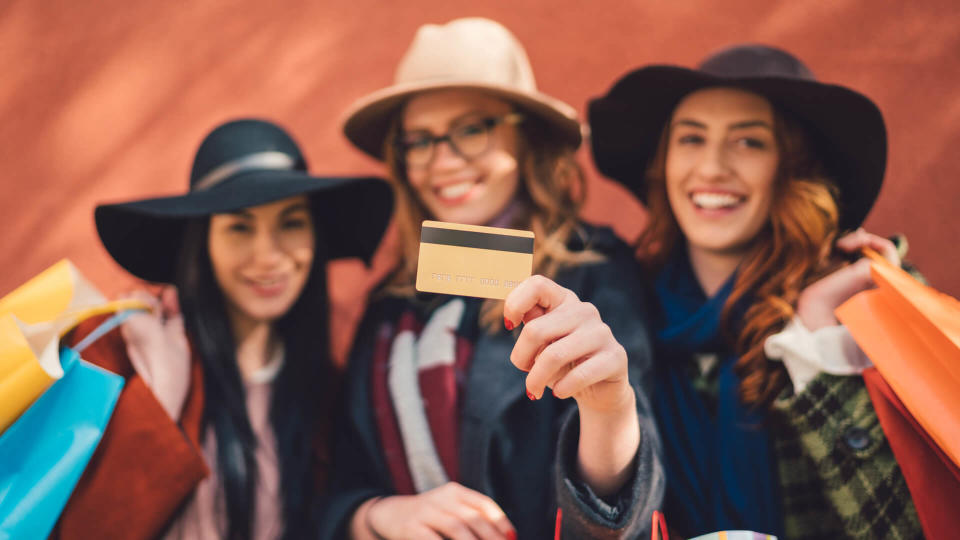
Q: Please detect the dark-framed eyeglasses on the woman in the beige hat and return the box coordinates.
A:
[397,113,523,167]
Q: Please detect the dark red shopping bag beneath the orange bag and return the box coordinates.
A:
[863,368,960,538]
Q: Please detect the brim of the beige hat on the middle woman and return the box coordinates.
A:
[343,81,583,161]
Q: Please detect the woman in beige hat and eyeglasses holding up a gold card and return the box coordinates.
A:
[323,19,662,539]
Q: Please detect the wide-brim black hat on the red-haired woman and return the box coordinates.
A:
[588,45,887,230]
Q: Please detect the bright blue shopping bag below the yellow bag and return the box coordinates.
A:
[0,346,124,540]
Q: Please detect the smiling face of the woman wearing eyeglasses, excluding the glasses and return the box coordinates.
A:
[401,90,519,225]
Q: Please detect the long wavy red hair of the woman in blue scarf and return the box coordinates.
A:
[637,108,838,407]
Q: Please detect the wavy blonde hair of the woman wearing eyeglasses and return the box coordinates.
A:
[378,101,601,333]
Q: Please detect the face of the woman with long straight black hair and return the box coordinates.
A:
[208,195,314,327]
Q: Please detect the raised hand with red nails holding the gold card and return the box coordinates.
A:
[503,276,640,496]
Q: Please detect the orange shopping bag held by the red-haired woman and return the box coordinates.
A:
[835,249,960,465]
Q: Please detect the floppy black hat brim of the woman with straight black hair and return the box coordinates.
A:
[94,171,393,283]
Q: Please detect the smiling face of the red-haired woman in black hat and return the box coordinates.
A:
[666,88,780,262]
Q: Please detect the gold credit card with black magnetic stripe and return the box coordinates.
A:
[417,221,533,300]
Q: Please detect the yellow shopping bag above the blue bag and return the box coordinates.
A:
[0,260,149,433]
